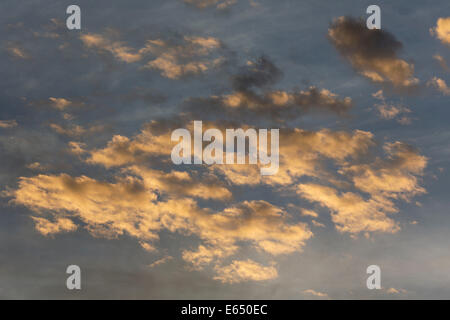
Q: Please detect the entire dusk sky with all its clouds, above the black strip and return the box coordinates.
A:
[0,0,450,299]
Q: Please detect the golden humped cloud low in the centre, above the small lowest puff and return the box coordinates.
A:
[183,200,313,269]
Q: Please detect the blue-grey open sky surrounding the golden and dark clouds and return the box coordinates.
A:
[0,0,450,299]
